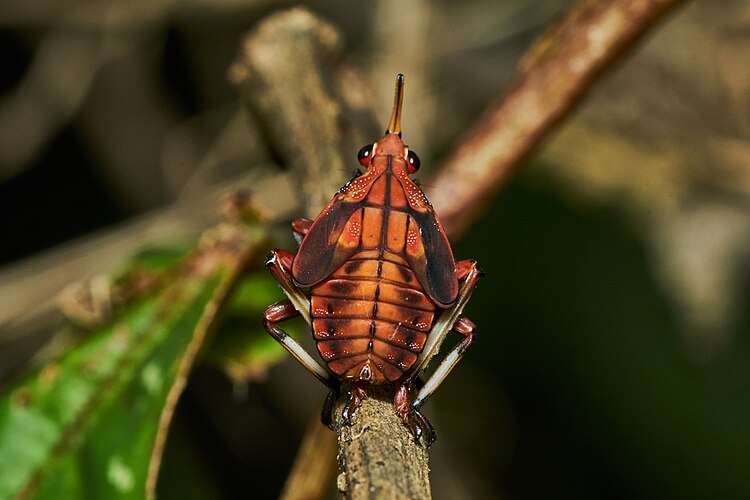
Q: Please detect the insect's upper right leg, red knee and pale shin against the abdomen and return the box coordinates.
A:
[411,260,484,378]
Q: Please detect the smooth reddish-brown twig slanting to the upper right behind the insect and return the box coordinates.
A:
[428,0,685,237]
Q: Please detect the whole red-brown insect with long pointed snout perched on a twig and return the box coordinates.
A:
[264,75,482,446]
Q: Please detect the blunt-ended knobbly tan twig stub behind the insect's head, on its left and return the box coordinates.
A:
[229,8,374,217]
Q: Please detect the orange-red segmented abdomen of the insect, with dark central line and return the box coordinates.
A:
[310,214,437,384]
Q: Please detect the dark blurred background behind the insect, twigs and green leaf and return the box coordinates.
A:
[0,0,750,499]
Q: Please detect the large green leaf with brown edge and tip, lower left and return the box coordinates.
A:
[0,225,262,499]
